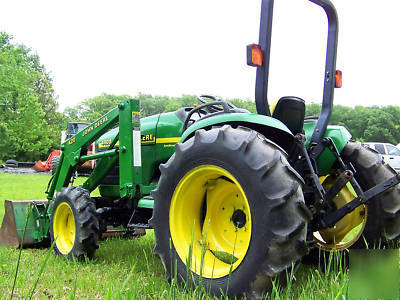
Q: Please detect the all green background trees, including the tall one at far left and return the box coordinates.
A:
[0,32,400,161]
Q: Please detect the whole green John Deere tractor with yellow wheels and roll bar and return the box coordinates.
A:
[0,0,400,296]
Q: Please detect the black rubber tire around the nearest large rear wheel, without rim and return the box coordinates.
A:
[150,125,311,297]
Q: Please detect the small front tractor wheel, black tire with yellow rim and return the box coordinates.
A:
[50,186,99,261]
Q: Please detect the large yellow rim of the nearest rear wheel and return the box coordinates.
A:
[169,165,251,278]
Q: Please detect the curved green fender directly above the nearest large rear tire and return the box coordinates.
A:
[179,113,295,151]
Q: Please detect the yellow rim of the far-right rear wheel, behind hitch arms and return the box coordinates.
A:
[314,176,367,251]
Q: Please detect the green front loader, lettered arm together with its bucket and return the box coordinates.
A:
[0,100,142,247]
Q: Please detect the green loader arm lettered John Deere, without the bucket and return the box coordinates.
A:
[46,100,142,204]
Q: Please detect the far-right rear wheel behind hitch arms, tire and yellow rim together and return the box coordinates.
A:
[303,141,400,267]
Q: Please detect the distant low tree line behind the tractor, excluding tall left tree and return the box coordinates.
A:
[64,94,400,145]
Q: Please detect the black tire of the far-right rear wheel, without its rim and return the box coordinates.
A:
[342,141,400,248]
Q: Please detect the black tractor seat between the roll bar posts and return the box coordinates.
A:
[272,97,306,135]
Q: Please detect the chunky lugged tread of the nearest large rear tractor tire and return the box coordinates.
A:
[150,125,310,297]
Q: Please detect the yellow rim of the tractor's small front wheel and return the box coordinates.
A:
[53,202,75,255]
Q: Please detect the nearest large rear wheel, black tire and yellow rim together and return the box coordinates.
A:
[150,126,310,296]
